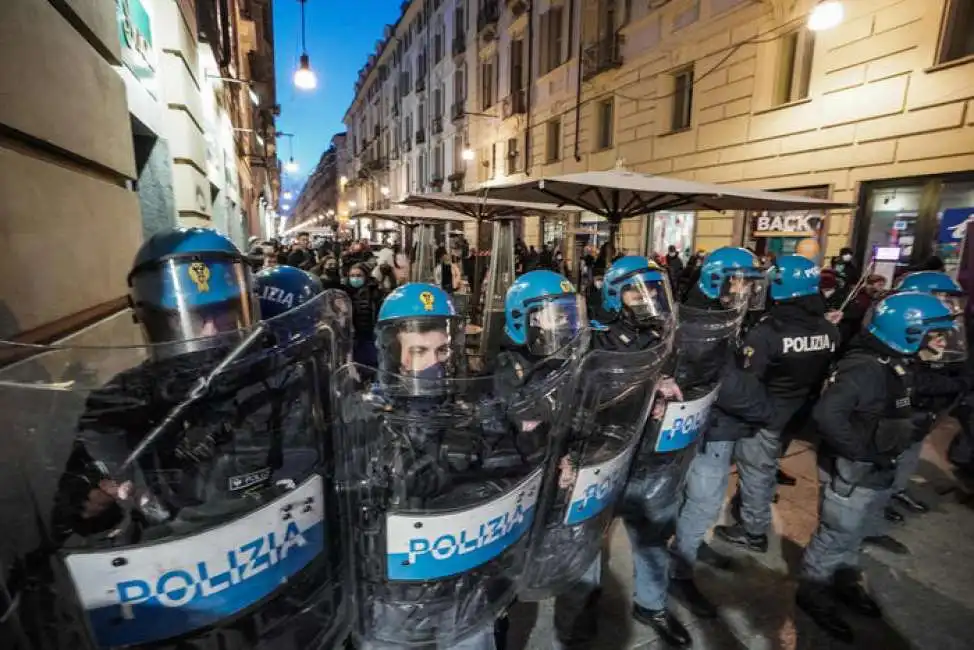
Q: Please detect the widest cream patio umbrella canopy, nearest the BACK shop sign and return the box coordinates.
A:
[465,170,849,252]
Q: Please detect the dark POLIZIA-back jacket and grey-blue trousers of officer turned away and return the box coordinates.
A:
[718,293,839,543]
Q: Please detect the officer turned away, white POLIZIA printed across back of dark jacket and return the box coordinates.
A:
[713,255,839,553]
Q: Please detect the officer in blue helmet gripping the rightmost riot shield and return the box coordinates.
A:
[663,247,774,620]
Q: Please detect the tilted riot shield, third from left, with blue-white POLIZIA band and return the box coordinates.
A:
[518,338,672,600]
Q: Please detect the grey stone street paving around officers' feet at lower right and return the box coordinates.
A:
[509,422,974,650]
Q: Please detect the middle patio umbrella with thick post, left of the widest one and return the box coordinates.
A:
[402,193,578,358]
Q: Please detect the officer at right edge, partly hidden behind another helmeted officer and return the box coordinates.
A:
[864,271,971,554]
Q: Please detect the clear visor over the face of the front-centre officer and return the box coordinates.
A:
[376,317,464,397]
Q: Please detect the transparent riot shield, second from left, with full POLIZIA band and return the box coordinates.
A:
[334,340,577,648]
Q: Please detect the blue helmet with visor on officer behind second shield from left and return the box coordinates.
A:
[375,283,464,396]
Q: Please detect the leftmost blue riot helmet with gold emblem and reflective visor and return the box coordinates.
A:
[128,228,259,354]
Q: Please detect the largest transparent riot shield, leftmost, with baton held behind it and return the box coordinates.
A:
[0,292,351,650]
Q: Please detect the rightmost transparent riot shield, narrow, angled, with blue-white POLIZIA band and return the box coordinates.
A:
[620,305,746,516]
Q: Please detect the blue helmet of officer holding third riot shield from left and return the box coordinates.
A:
[602,255,673,326]
